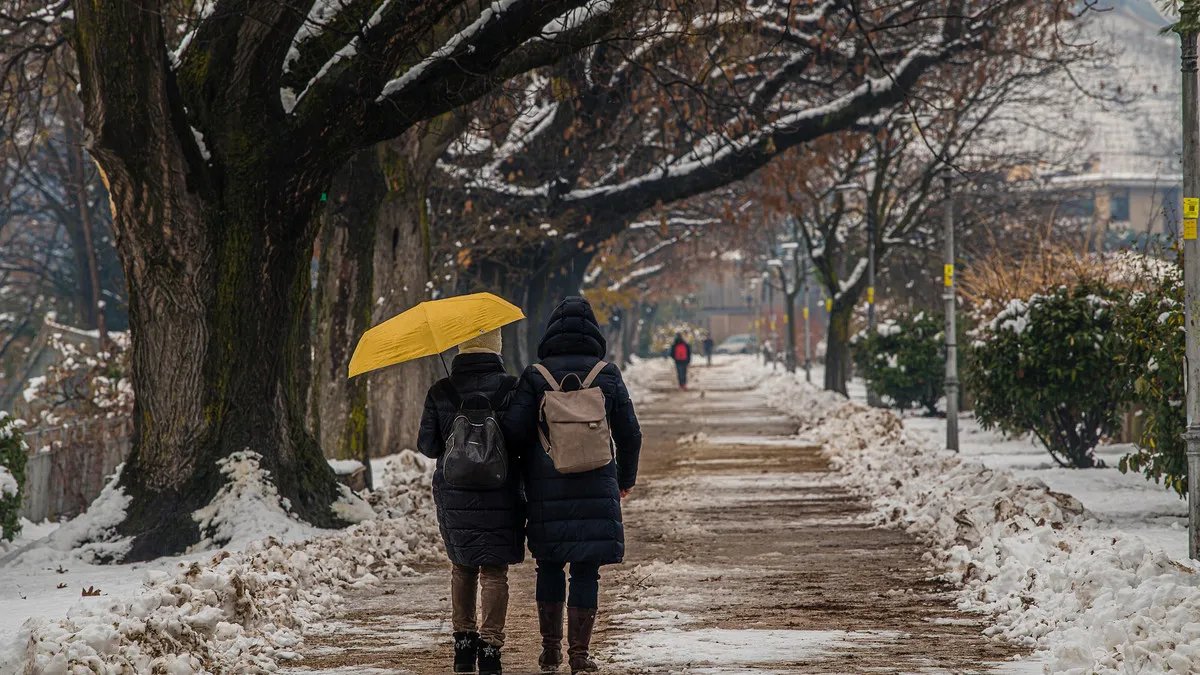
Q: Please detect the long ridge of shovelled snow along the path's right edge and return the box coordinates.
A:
[762,365,1200,674]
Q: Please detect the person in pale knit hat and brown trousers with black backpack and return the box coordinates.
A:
[416,329,524,674]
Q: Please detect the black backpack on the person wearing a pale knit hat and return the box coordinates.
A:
[442,380,512,490]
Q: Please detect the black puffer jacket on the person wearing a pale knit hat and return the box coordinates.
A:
[416,354,524,567]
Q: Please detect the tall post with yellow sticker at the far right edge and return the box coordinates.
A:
[1176,0,1200,560]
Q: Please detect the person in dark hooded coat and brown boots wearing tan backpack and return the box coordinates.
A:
[502,297,642,673]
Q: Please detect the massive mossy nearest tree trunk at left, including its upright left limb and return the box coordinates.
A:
[72,4,341,560]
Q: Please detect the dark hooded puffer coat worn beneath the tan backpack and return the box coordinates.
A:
[503,298,642,565]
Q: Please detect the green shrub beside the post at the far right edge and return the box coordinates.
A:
[1117,268,1188,496]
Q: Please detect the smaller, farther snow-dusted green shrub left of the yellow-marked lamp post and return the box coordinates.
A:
[851,312,946,414]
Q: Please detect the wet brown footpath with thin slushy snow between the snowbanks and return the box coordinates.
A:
[290,363,1016,673]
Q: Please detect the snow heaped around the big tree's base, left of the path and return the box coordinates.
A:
[0,452,440,674]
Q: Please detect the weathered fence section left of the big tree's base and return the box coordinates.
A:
[20,419,132,522]
